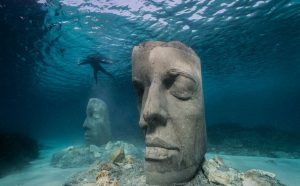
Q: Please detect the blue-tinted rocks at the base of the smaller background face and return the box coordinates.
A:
[51,141,143,168]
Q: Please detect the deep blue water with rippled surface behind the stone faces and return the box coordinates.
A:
[0,0,300,182]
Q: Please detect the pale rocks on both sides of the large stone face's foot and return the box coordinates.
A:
[64,146,283,186]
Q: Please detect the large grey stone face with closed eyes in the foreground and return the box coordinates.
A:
[132,41,206,185]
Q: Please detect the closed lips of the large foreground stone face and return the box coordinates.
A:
[145,138,179,161]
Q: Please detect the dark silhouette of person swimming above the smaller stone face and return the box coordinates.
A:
[78,54,115,84]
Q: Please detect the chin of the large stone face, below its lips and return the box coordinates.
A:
[145,166,198,185]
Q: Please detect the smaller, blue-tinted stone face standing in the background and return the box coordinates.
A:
[83,98,111,146]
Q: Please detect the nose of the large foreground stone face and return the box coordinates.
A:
[139,85,167,128]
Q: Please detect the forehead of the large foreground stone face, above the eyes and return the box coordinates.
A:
[133,47,200,79]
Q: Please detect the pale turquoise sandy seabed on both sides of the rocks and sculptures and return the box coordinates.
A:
[0,141,300,186]
